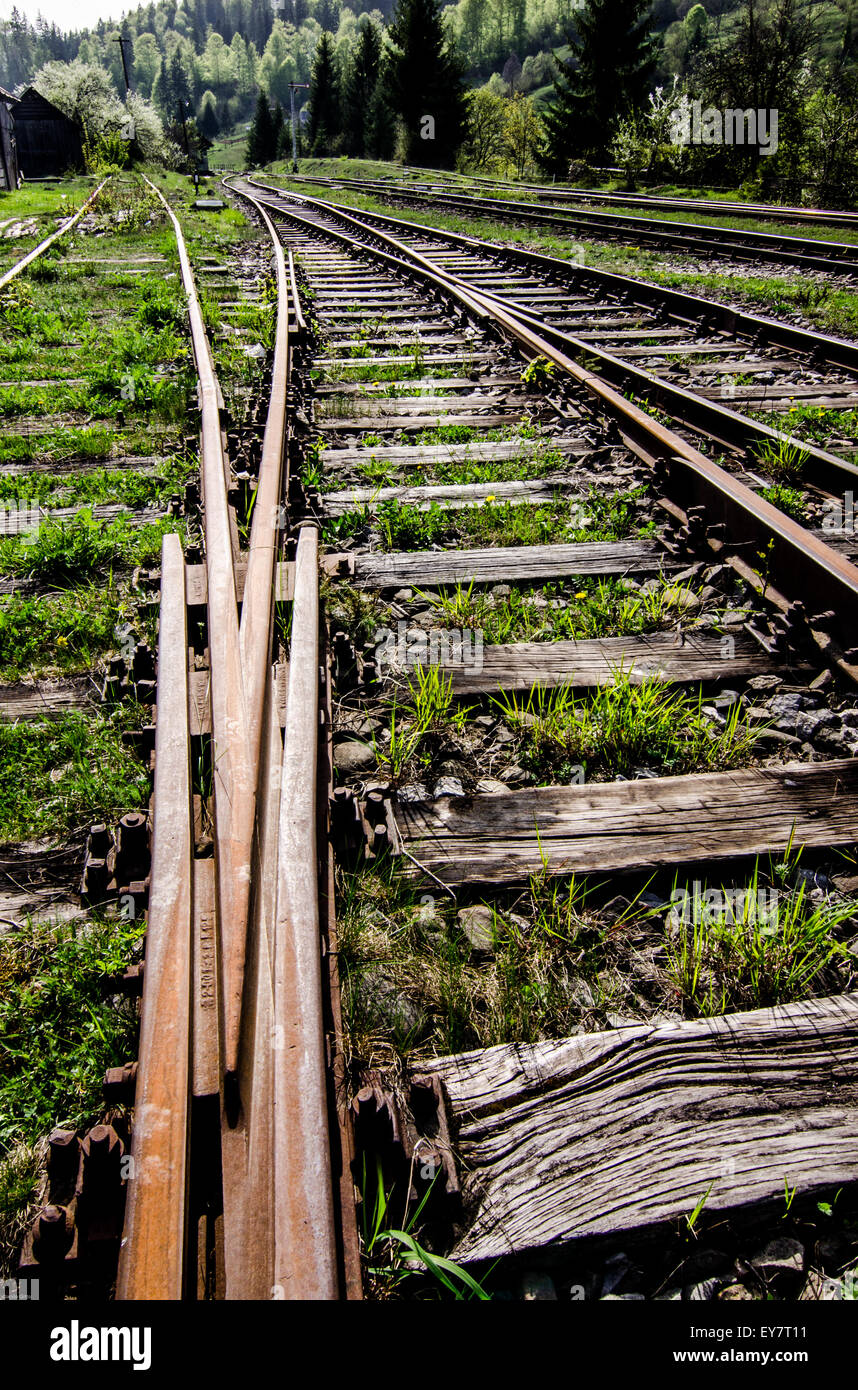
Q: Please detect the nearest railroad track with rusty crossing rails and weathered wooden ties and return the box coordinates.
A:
[15,173,858,1300]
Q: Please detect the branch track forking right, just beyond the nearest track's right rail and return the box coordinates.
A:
[246,183,858,489]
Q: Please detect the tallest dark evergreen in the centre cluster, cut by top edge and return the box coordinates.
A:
[388,0,467,165]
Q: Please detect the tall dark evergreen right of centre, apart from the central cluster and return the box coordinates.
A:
[545,0,656,174]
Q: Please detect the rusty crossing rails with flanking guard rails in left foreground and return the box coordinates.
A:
[118,179,351,1300]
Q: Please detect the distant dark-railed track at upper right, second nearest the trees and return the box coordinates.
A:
[278,175,858,277]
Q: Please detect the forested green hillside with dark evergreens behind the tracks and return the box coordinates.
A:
[0,0,858,200]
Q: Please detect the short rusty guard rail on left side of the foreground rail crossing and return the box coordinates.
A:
[117,535,193,1300]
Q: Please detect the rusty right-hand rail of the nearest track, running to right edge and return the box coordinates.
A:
[246,177,858,661]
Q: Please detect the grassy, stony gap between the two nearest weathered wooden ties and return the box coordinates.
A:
[338,855,858,1077]
